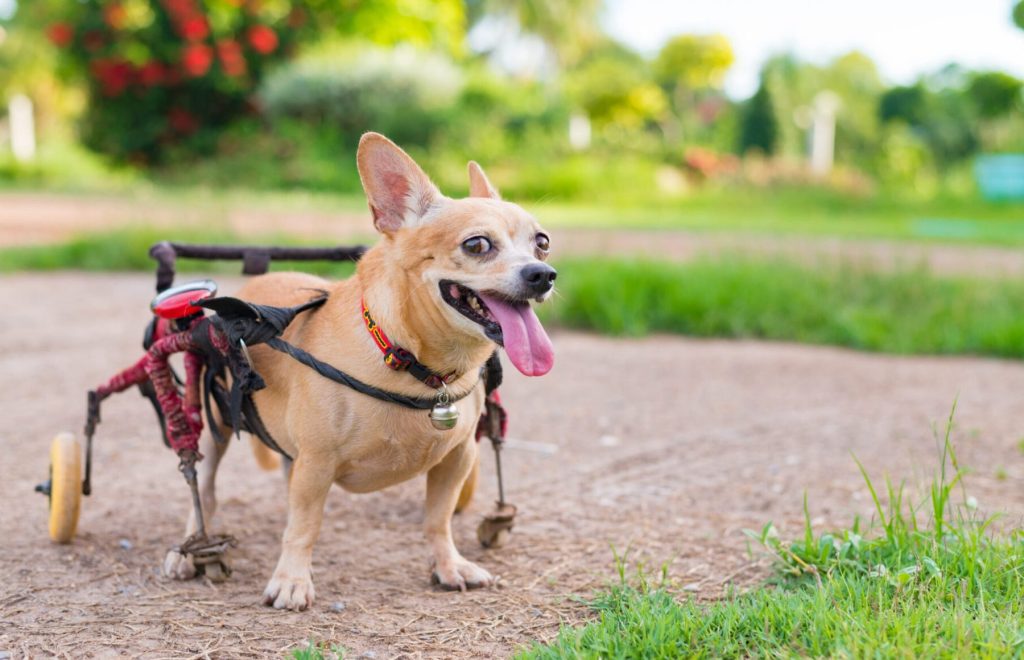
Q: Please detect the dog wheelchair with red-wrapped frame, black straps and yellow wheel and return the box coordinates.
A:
[36,241,516,581]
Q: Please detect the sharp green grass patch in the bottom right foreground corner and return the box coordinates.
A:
[519,403,1024,659]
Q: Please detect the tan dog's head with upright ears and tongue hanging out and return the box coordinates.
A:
[356,133,556,376]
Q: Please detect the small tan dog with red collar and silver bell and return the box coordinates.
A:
[164,133,556,610]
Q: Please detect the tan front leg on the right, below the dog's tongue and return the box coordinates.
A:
[425,438,495,590]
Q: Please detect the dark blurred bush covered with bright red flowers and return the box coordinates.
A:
[46,0,303,164]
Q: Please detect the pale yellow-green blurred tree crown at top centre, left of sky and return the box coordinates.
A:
[468,0,604,68]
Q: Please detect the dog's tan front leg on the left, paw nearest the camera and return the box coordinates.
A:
[263,454,335,610]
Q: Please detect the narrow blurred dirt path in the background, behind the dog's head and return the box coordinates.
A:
[0,192,1024,276]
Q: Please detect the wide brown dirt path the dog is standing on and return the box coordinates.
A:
[0,274,1024,658]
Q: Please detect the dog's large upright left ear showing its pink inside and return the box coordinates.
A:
[355,133,441,233]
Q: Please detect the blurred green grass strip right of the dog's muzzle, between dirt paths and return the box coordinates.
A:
[541,257,1024,358]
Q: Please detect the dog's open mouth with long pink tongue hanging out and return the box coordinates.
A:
[439,279,555,376]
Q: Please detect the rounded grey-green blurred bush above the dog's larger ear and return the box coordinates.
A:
[259,44,463,145]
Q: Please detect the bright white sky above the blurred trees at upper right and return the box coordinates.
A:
[603,0,1024,97]
